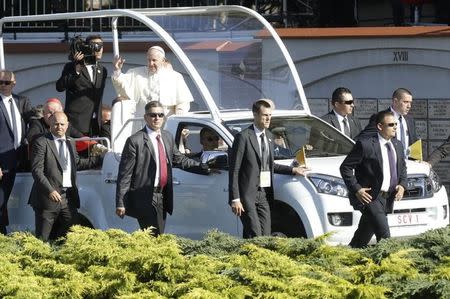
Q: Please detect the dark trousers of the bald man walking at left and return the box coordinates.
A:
[35,193,78,241]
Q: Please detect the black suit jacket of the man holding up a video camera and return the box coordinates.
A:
[56,62,108,133]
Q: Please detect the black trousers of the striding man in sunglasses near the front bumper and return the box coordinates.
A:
[349,196,391,248]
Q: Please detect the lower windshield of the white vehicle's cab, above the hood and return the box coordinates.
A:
[225,116,353,159]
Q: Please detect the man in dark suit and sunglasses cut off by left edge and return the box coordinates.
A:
[0,70,32,234]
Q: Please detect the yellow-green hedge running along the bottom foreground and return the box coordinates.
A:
[0,226,450,298]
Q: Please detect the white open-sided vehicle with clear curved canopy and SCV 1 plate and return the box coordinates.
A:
[0,6,449,244]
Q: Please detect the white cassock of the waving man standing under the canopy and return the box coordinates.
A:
[111,66,194,117]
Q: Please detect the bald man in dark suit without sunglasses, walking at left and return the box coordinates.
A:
[28,112,97,241]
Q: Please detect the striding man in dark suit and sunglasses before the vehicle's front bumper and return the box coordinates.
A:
[340,111,407,248]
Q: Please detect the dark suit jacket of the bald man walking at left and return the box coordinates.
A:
[28,134,98,210]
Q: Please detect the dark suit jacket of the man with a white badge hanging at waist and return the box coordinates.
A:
[228,125,292,208]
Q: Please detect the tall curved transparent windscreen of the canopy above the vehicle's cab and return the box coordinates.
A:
[130,7,304,111]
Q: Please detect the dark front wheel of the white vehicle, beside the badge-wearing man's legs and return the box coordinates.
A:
[271,200,307,238]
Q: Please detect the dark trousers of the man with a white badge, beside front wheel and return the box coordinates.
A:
[241,189,272,239]
